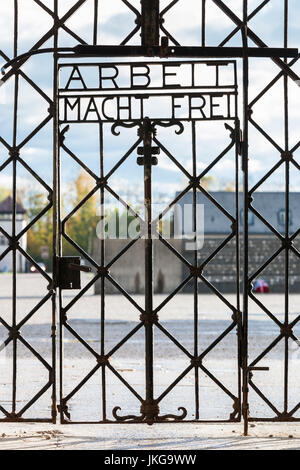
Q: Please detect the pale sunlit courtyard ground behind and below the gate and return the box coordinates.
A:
[0,274,300,449]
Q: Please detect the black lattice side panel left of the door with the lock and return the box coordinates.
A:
[0,0,56,422]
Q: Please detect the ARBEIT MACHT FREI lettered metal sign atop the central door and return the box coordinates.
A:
[58,61,237,124]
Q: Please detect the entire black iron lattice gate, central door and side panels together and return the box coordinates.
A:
[0,0,300,434]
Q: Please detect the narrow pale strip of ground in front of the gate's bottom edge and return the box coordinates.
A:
[0,424,300,451]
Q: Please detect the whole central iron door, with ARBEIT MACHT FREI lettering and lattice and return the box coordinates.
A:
[58,61,241,424]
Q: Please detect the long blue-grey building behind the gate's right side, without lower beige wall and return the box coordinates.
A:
[174,191,300,292]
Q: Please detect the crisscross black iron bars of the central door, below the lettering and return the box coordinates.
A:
[56,54,241,424]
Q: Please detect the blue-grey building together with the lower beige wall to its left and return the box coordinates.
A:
[94,191,300,293]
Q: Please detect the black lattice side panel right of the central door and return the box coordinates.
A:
[243,0,300,434]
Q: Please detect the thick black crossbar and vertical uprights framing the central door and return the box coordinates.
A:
[1,0,300,434]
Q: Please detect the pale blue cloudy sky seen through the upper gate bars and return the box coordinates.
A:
[0,0,300,208]
